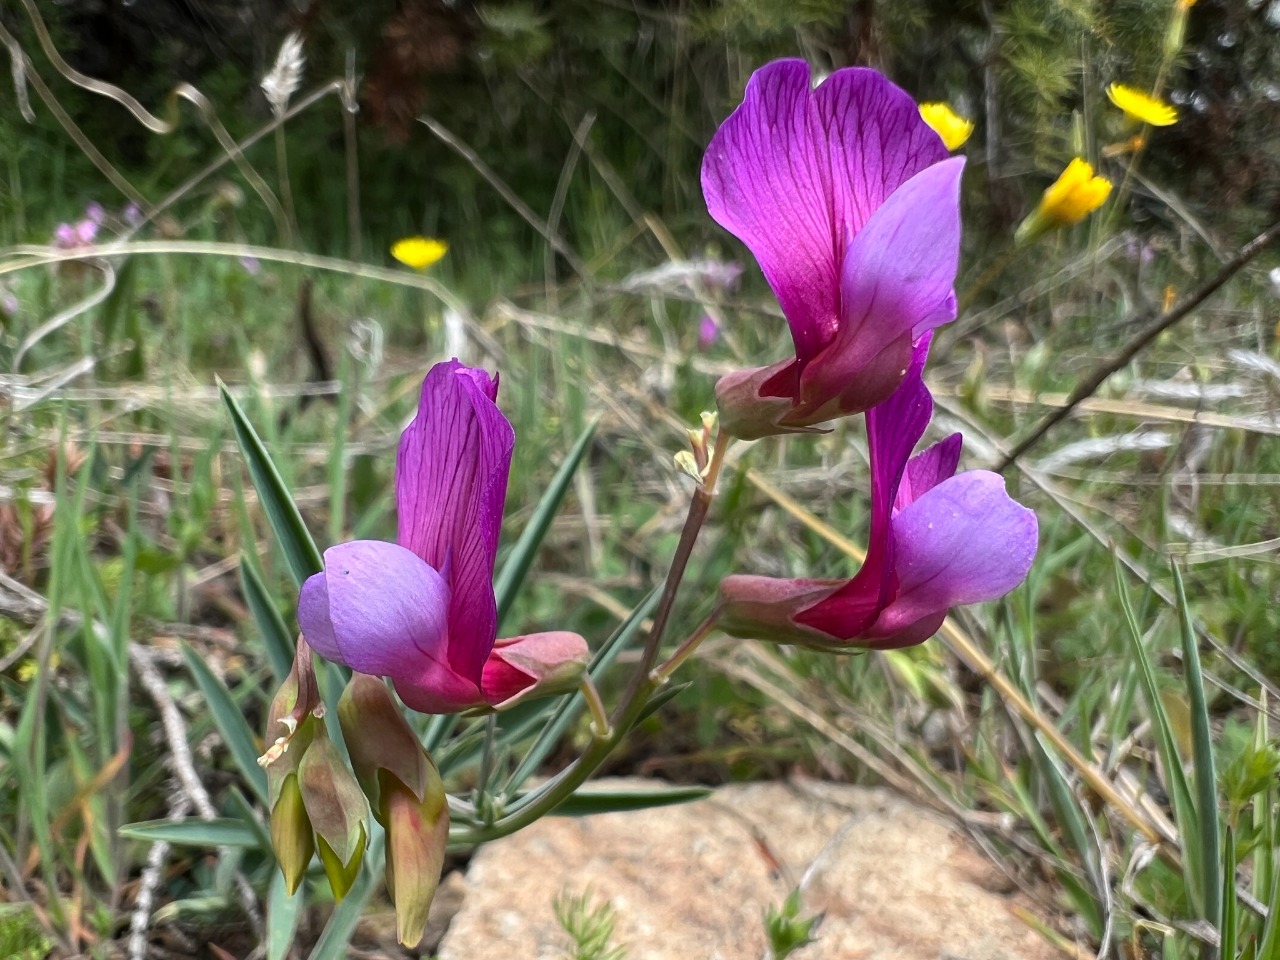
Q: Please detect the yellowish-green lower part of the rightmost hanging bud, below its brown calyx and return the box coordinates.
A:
[379,764,449,947]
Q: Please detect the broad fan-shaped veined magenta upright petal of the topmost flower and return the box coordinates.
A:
[703,60,947,362]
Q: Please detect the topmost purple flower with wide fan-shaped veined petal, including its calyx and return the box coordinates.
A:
[703,60,964,439]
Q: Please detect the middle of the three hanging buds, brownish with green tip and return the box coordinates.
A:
[298,727,369,900]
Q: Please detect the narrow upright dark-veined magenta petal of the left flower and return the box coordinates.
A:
[396,360,516,686]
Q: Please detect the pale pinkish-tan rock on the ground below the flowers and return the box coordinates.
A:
[439,782,1061,960]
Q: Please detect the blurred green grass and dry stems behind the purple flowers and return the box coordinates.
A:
[0,0,1280,957]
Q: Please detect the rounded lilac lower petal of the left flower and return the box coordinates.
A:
[298,540,449,678]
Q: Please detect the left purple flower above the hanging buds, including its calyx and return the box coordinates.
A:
[298,360,588,713]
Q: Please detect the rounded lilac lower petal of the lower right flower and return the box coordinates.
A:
[872,470,1038,636]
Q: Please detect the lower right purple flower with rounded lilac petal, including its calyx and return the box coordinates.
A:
[718,337,1038,649]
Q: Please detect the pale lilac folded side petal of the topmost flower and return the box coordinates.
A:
[797,157,964,416]
